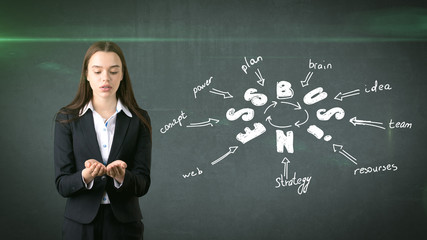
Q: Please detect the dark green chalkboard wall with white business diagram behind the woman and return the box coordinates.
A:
[0,0,427,239]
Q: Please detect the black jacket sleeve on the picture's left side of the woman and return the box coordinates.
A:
[54,113,85,197]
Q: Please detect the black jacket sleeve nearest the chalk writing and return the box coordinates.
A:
[117,111,152,197]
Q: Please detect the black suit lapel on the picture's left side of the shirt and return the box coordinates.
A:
[80,110,102,162]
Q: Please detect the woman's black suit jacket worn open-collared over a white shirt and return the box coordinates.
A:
[54,109,151,224]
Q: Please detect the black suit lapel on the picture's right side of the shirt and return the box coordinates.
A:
[107,111,130,164]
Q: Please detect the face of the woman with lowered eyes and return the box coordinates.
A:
[86,51,123,99]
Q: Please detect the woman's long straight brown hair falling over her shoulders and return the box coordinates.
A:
[59,41,151,135]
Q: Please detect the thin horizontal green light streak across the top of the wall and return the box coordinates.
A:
[0,37,427,43]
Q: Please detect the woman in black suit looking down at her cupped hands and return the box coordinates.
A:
[54,42,151,240]
